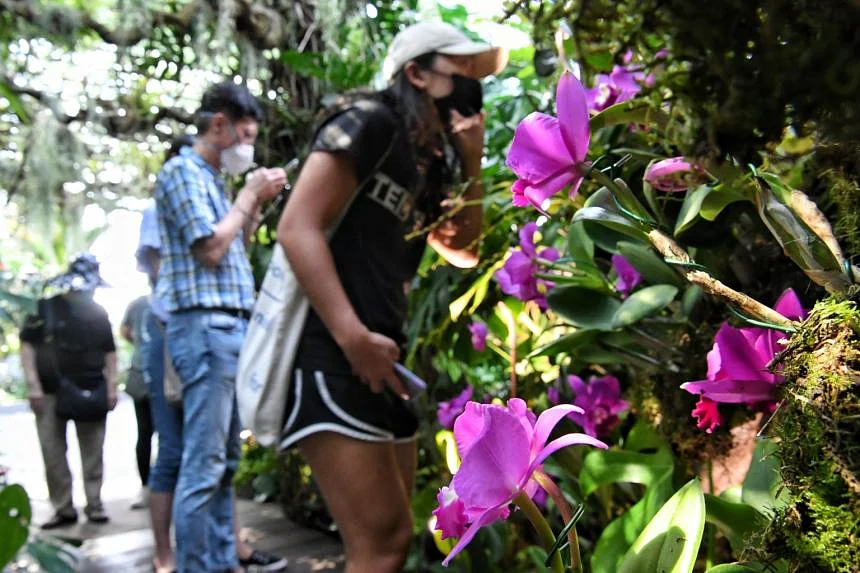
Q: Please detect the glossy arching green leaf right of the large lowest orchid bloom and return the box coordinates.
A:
[579,450,673,496]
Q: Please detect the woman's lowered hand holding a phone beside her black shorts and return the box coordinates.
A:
[342,328,407,396]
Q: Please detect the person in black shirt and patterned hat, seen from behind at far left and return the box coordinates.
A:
[20,253,117,529]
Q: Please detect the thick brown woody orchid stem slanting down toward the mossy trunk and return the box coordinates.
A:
[648,229,796,330]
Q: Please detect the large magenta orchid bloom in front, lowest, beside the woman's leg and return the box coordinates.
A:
[433,398,607,566]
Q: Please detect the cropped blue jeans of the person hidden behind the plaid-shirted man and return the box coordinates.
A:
[141,311,182,493]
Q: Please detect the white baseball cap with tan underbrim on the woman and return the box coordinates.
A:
[382,22,508,80]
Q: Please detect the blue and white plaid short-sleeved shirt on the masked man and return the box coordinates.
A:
[155,147,254,312]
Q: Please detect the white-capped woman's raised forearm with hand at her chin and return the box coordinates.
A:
[427,110,484,269]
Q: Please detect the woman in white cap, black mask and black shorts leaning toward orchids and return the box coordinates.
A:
[278,23,507,573]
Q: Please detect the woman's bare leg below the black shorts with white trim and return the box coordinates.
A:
[299,432,414,573]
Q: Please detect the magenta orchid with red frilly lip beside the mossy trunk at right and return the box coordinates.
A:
[681,289,806,424]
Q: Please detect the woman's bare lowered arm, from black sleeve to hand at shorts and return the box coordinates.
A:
[278,151,406,395]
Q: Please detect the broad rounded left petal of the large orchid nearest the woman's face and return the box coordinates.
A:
[507,112,574,183]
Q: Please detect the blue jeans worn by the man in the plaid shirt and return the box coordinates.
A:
[167,310,248,573]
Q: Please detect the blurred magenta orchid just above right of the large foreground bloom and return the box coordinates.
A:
[549,376,630,438]
